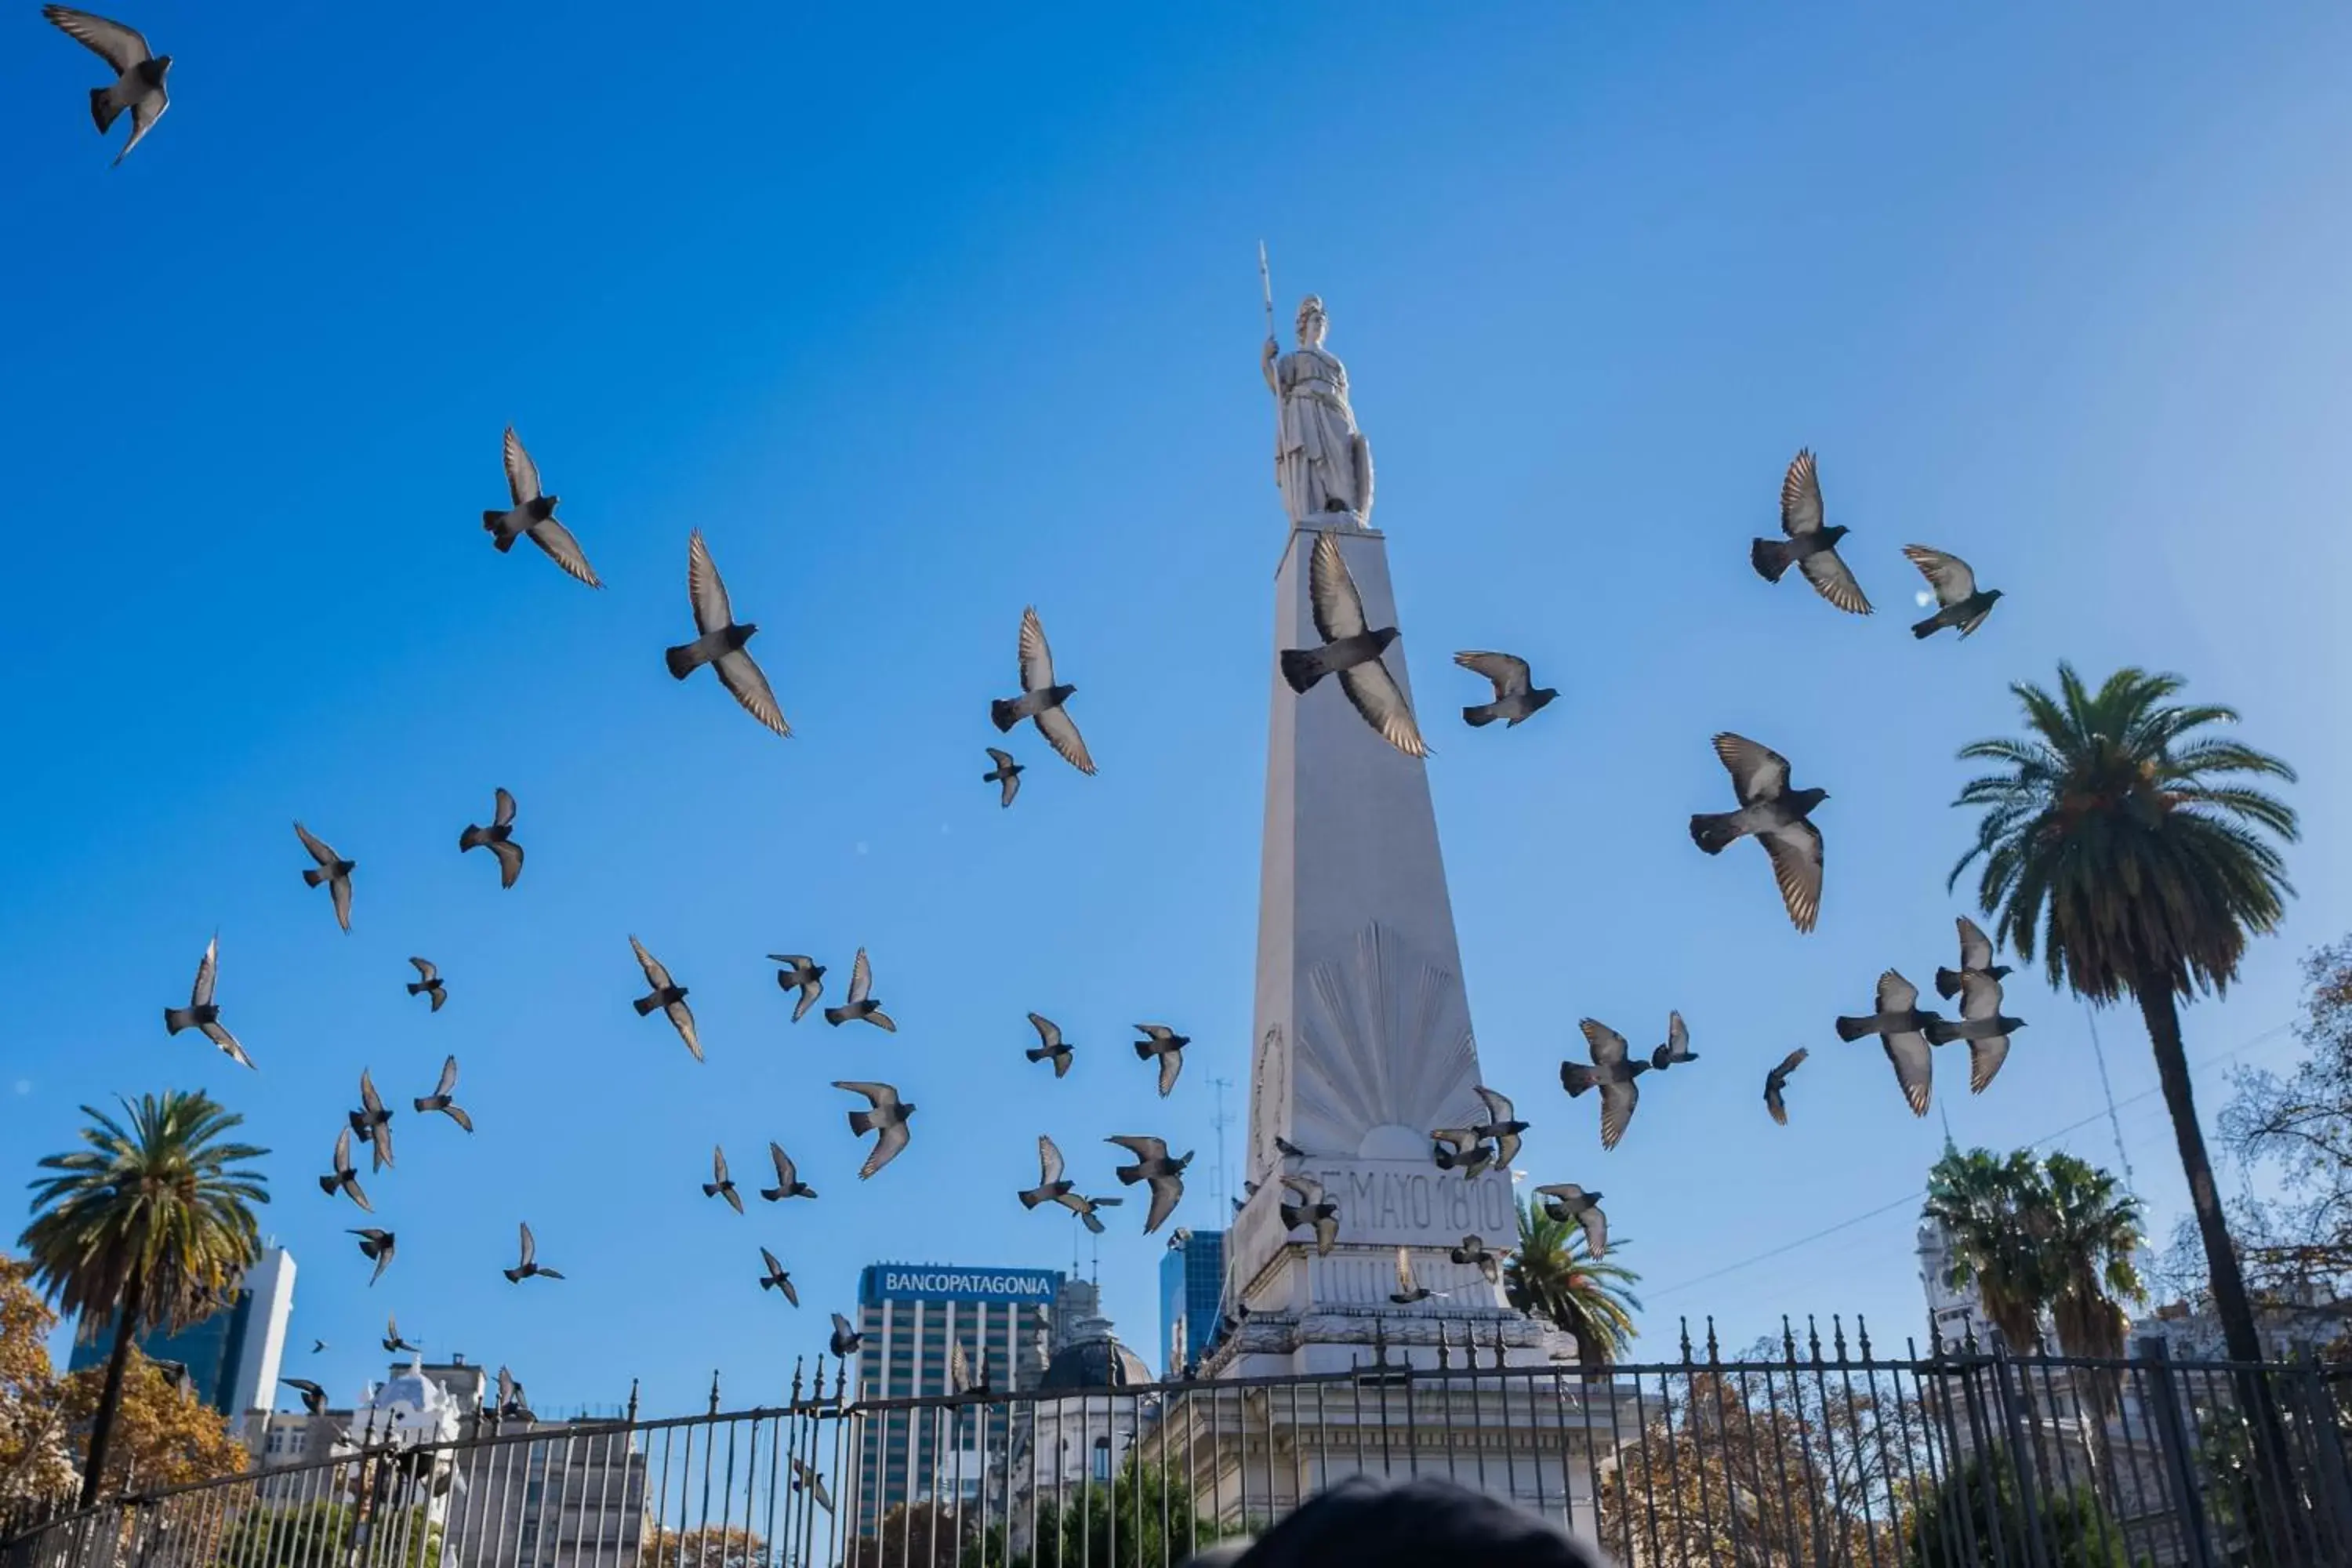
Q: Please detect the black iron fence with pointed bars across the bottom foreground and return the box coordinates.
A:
[0,1323,2352,1568]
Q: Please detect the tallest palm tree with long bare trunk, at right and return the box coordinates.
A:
[1952,666,2296,1361]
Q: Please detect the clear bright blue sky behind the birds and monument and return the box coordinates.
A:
[0,0,2352,1410]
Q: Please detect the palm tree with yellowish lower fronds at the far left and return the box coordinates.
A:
[24,1088,270,1507]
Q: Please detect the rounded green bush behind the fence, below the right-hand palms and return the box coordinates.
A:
[1903,1448,2143,1568]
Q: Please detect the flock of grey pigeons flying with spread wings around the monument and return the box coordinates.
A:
[42,5,2023,1415]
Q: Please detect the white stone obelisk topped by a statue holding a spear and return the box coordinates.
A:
[1202,296,1557,1377]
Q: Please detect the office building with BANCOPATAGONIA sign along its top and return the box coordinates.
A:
[844,1262,1065,1533]
